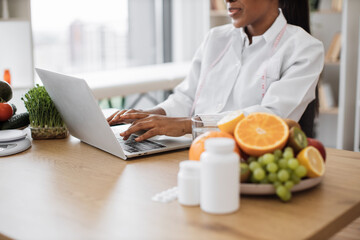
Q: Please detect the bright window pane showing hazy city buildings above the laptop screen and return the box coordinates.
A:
[31,0,128,73]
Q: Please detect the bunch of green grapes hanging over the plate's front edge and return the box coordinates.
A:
[247,147,307,201]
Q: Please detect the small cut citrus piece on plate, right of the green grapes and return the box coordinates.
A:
[296,146,325,178]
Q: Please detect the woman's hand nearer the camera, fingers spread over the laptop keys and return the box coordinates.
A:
[120,112,191,141]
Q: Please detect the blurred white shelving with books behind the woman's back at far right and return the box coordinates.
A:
[310,0,360,150]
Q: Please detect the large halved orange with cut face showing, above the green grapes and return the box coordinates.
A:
[234,113,289,156]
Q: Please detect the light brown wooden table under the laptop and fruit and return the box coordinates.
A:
[0,137,360,239]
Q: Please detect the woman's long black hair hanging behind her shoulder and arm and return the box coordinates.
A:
[279,0,319,137]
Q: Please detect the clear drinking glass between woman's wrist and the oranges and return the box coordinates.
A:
[191,115,221,140]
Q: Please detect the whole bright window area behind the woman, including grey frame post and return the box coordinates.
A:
[31,0,209,108]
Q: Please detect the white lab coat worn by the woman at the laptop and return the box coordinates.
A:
[158,11,324,121]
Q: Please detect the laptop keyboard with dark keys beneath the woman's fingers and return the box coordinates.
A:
[116,134,165,153]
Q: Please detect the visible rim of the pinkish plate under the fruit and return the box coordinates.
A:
[240,177,323,195]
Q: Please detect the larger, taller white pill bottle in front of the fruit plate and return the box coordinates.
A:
[200,138,240,214]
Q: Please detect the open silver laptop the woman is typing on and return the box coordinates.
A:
[36,68,192,160]
